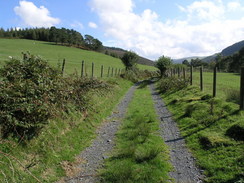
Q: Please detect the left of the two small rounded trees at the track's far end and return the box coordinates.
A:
[121,51,139,70]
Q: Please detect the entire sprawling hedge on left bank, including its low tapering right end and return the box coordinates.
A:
[0,54,110,138]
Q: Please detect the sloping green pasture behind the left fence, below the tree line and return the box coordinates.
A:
[0,39,155,76]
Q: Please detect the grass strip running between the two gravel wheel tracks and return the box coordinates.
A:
[102,81,170,183]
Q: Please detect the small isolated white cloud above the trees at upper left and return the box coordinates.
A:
[14,1,60,27]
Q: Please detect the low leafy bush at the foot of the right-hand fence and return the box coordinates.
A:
[158,77,189,93]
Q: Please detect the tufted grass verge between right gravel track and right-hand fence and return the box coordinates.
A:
[159,78,244,183]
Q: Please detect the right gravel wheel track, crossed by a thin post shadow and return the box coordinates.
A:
[150,83,203,183]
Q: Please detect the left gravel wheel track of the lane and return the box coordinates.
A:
[66,85,136,183]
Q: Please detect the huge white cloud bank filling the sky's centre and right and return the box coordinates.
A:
[91,0,244,59]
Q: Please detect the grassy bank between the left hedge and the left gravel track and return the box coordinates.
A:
[0,78,131,183]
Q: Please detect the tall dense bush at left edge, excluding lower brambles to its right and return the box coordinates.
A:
[0,54,60,137]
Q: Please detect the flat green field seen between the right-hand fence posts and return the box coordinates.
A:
[193,72,240,100]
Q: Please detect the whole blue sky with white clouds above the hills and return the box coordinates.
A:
[0,0,244,60]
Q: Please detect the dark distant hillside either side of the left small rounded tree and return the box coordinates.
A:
[104,46,154,66]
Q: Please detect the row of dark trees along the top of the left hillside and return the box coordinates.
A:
[0,26,103,51]
